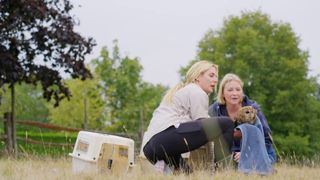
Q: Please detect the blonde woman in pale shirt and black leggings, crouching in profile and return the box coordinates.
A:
[141,61,234,173]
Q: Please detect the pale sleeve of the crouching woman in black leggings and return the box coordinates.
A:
[189,90,209,120]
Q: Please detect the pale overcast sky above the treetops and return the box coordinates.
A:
[71,0,320,86]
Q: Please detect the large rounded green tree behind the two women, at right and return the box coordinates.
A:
[189,11,320,155]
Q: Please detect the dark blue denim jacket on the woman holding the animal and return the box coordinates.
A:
[209,96,277,163]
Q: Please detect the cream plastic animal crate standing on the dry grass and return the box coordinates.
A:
[69,131,134,173]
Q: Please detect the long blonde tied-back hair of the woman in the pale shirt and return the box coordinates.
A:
[162,60,218,104]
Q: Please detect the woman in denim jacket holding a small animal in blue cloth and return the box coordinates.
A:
[209,73,277,174]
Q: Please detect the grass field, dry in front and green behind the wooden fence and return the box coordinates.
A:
[0,128,320,180]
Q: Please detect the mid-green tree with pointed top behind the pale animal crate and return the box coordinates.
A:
[94,41,165,133]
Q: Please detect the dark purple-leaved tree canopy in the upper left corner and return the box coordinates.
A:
[0,0,94,105]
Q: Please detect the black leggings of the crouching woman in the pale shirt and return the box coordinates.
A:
[143,117,234,168]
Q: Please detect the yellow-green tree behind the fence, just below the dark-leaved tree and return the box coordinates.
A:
[48,78,105,129]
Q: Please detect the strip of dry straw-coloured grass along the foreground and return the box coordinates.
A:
[0,157,320,180]
